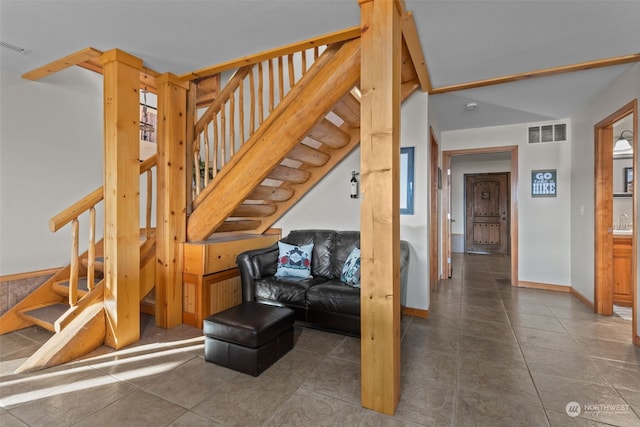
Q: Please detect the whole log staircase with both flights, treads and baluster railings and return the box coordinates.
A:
[0,22,428,372]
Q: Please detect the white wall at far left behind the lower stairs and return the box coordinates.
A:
[0,67,103,275]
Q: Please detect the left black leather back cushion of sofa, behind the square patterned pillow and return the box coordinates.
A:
[282,230,338,279]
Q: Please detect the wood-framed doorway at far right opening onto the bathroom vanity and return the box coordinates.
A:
[594,100,640,345]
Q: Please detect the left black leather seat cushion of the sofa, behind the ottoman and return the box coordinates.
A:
[255,276,326,307]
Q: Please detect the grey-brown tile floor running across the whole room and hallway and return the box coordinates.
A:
[0,254,640,427]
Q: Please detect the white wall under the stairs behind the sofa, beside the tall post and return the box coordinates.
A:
[274,93,429,310]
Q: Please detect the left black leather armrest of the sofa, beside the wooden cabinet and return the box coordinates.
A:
[236,243,278,301]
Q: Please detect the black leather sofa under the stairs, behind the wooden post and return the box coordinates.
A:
[236,230,410,335]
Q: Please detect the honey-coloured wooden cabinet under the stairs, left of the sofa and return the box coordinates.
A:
[182,230,280,328]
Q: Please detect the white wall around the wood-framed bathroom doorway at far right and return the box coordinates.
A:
[571,64,640,340]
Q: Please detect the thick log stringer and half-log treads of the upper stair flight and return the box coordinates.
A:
[187,39,360,241]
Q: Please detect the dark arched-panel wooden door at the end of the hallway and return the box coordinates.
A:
[465,173,510,255]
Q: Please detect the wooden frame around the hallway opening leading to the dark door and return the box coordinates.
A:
[441,145,519,286]
